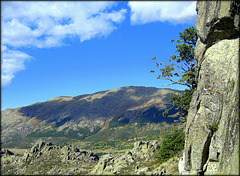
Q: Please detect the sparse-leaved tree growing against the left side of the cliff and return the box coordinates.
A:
[151,27,197,122]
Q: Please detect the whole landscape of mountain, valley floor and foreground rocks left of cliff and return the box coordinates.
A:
[1,86,181,175]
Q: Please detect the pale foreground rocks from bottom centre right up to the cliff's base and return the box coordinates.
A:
[88,141,182,175]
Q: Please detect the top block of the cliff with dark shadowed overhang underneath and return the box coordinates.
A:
[196,1,240,46]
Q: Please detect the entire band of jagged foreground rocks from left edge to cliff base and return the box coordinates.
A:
[1,141,181,175]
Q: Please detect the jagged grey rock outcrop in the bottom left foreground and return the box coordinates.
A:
[1,141,99,175]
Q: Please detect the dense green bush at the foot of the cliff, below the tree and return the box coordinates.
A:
[154,126,185,164]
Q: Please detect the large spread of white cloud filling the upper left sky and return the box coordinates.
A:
[1,1,126,87]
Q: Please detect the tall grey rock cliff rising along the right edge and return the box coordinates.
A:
[179,1,240,175]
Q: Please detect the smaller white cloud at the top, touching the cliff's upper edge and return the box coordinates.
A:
[128,1,197,24]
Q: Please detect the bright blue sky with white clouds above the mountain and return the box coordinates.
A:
[1,1,197,110]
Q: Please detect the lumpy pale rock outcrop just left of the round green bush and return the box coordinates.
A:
[90,141,159,175]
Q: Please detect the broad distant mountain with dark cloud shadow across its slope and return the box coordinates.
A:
[1,86,181,146]
